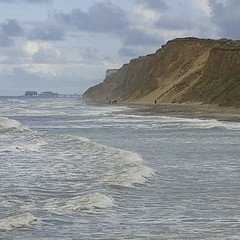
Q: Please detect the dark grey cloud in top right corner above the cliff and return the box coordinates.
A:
[210,0,240,39]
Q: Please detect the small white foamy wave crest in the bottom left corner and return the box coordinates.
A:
[0,212,38,231]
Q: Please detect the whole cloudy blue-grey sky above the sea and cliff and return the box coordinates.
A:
[0,0,240,96]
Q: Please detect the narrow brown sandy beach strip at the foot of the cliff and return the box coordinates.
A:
[123,102,240,122]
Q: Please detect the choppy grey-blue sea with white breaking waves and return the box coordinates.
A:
[0,97,240,240]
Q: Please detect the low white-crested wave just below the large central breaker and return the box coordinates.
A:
[45,192,115,213]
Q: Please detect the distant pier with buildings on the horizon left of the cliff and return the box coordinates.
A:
[24,91,82,98]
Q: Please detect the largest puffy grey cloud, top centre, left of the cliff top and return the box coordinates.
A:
[55,3,128,34]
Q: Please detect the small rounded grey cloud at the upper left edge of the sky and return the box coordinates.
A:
[1,19,23,37]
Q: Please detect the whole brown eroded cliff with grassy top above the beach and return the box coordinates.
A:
[83,38,240,107]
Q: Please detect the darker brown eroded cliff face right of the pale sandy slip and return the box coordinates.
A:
[179,41,240,107]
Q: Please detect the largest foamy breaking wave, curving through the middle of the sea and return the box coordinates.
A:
[56,135,155,187]
